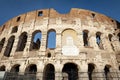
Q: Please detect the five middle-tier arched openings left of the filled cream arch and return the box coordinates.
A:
[0,30,56,57]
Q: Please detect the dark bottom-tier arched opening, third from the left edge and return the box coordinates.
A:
[25,64,37,80]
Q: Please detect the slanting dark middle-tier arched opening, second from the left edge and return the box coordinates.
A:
[4,36,15,57]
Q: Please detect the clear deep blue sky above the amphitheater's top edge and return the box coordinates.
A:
[0,0,120,25]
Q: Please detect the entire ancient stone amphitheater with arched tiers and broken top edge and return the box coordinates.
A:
[0,8,120,80]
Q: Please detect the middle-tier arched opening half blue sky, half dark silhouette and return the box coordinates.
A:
[30,30,42,50]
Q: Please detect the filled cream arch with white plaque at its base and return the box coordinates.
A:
[62,29,79,56]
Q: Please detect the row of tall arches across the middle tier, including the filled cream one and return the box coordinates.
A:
[0,29,120,57]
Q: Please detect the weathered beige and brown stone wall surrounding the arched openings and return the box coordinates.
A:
[0,9,120,79]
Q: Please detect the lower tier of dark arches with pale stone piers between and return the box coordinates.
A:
[0,61,120,80]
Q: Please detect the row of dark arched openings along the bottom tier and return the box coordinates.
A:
[0,63,115,80]
